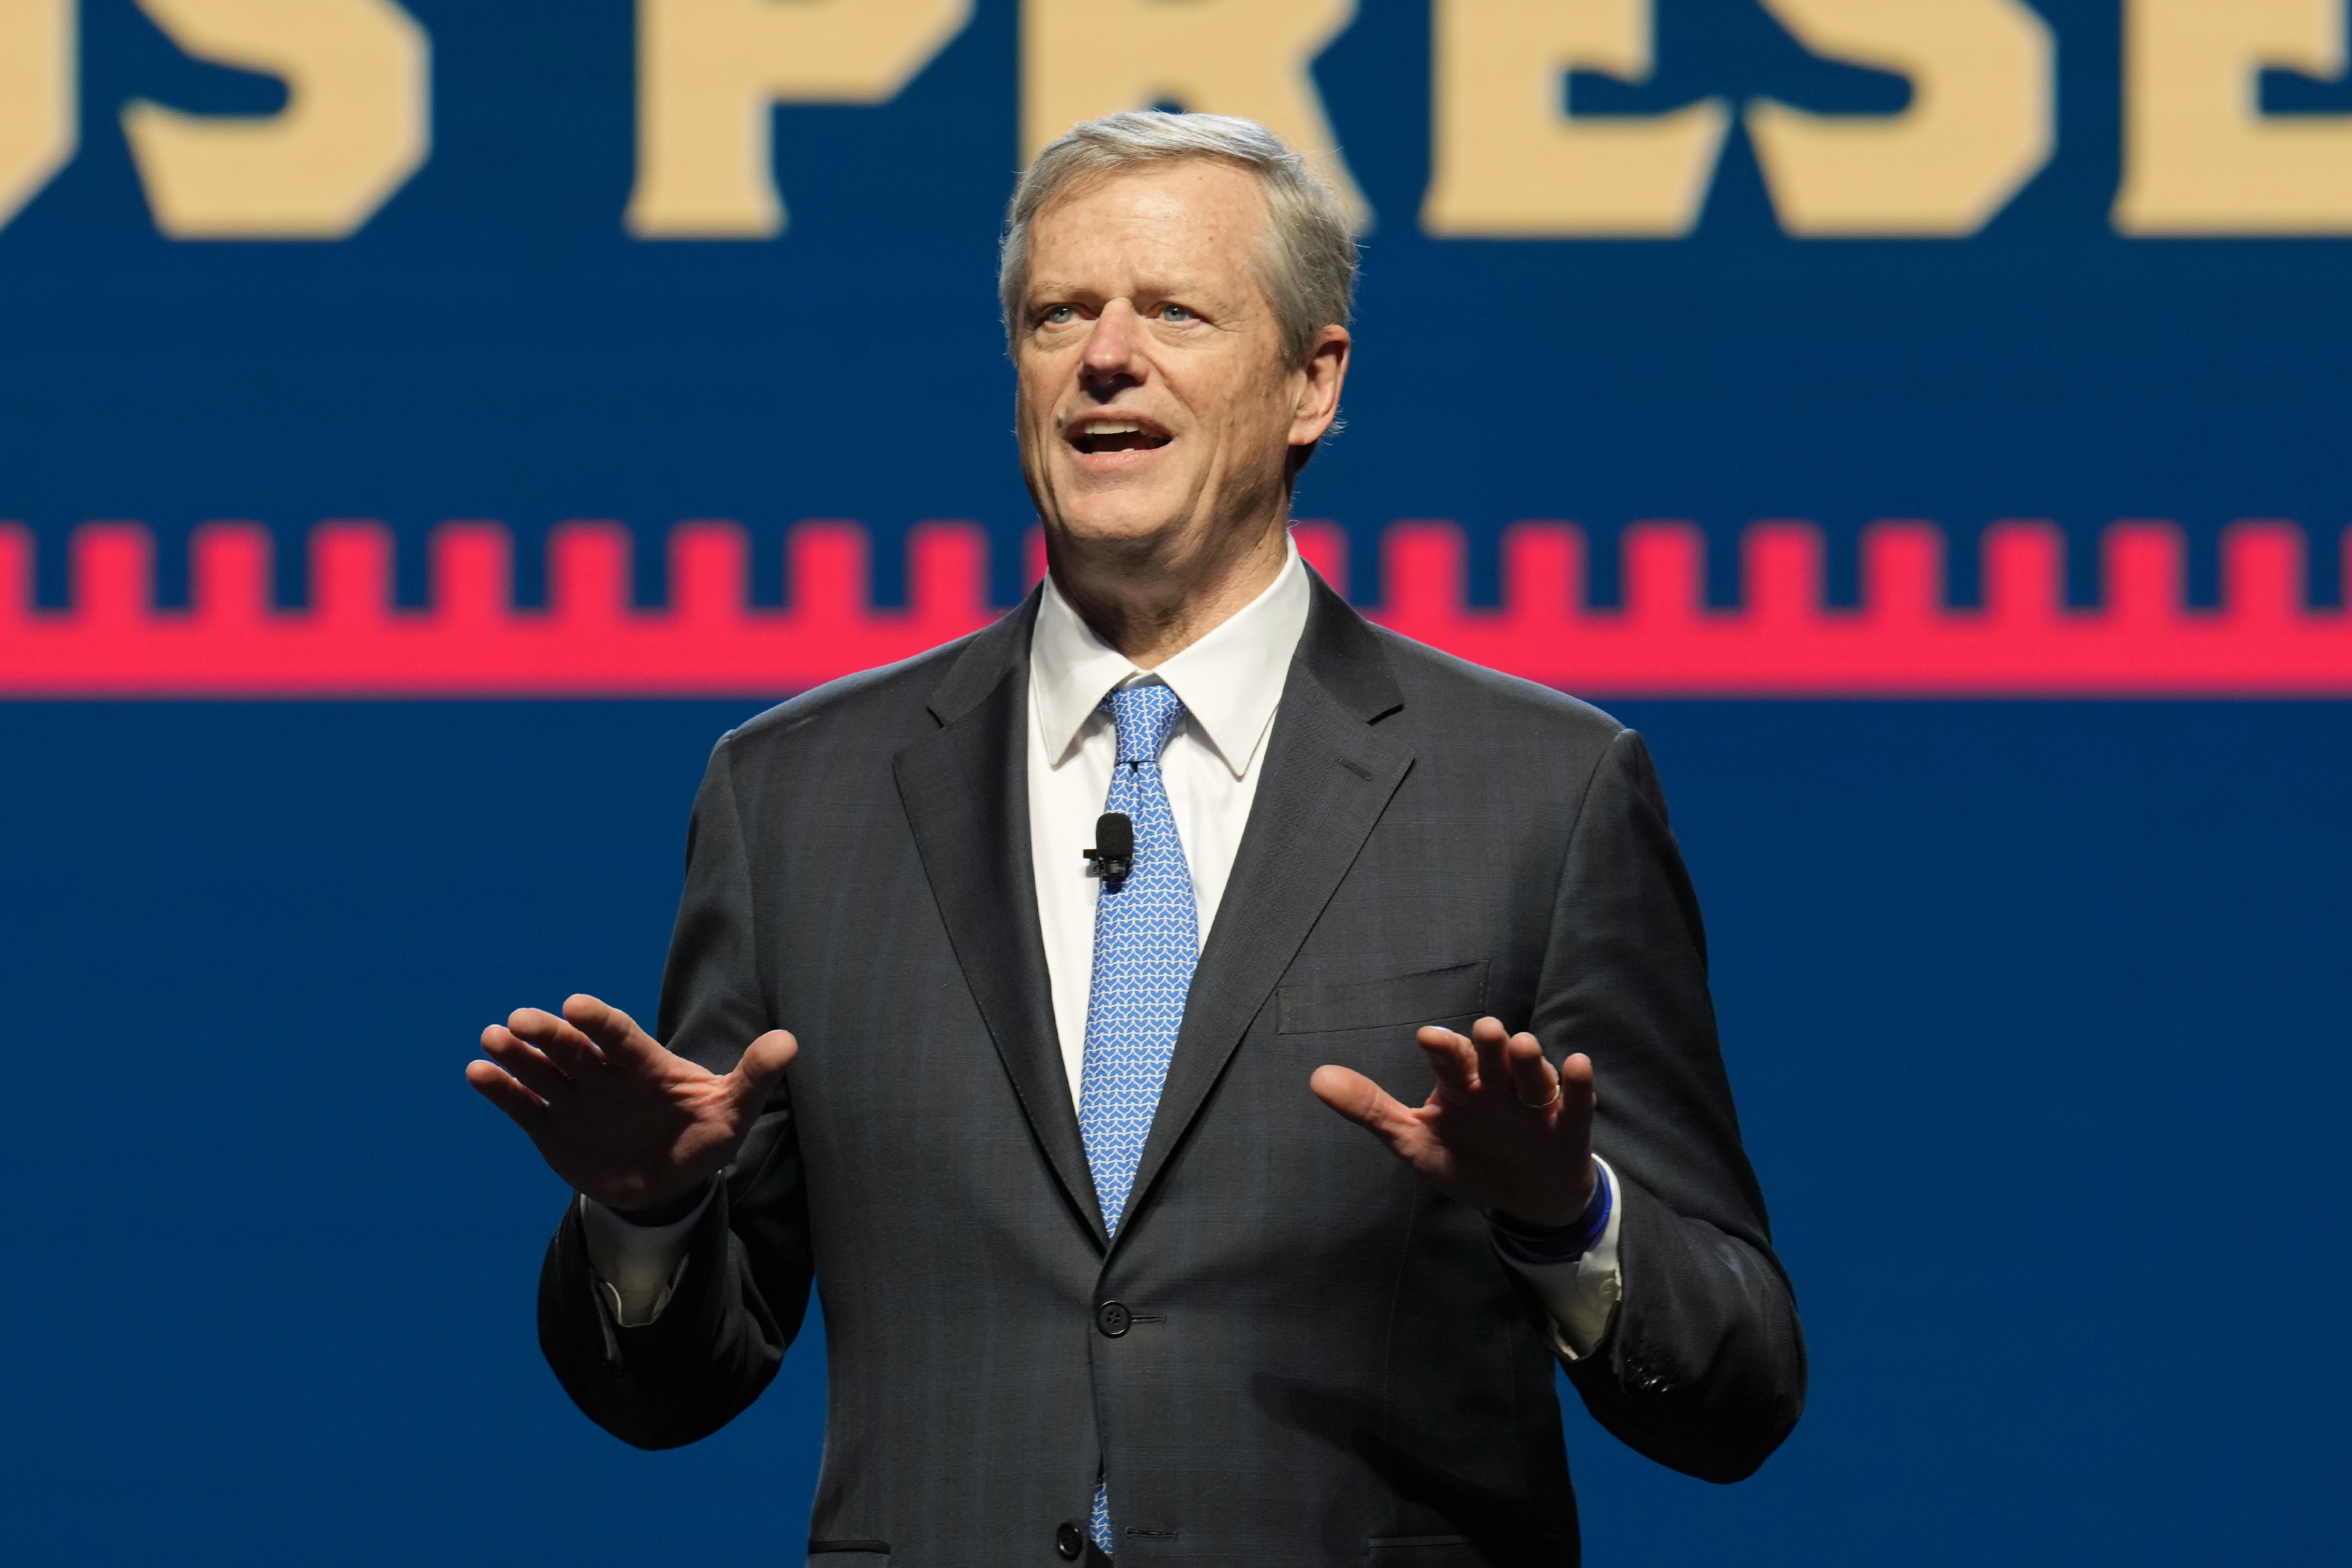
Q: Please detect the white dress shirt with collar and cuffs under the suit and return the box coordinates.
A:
[581,531,1623,1359]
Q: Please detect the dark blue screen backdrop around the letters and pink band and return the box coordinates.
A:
[0,0,2352,1563]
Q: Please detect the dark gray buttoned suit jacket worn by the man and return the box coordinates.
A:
[538,581,1804,1568]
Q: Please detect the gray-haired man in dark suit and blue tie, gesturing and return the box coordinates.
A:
[468,115,1804,1568]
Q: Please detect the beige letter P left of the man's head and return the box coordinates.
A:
[628,0,972,240]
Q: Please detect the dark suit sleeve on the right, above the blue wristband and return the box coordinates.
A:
[1533,728,1806,1481]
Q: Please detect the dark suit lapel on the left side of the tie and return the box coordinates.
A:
[894,595,1108,1243]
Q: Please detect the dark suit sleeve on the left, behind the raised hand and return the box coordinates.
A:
[538,736,814,1448]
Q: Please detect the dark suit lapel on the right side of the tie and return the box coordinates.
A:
[1120,569,1414,1237]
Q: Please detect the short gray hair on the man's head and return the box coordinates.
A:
[997,110,1355,369]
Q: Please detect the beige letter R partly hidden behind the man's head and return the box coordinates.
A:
[1021,0,1371,228]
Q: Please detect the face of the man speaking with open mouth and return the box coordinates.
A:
[1014,160,1345,564]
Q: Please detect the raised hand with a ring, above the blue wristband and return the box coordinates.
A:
[1308,1018,1599,1230]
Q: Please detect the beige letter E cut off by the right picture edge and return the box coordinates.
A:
[2114,0,2352,235]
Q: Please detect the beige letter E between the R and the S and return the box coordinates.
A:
[1420,0,1731,240]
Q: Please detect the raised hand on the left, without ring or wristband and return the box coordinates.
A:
[466,997,800,1208]
